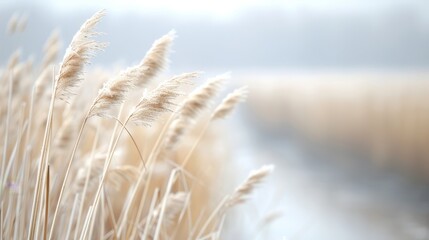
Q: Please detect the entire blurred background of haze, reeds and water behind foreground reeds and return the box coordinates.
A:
[0,0,429,240]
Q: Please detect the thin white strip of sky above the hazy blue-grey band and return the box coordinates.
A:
[4,0,429,12]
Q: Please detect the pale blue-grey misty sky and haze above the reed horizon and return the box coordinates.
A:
[0,0,429,70]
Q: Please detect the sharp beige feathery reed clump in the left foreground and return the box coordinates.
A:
[0,11,272,239]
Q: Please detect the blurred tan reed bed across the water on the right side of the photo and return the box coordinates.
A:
[246,70,429,177]
